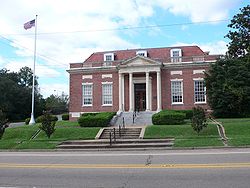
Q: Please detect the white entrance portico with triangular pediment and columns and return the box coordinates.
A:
[118,56,162,112]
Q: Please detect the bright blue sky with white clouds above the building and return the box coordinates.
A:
[0,0,249,97]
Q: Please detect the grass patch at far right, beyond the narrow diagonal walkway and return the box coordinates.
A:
[218,118,250,146]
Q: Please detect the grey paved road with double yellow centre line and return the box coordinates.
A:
[0,149,250,188]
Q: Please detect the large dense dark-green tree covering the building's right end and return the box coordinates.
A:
[205,57,250,117]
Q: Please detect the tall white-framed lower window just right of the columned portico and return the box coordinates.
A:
[171,81,183,104]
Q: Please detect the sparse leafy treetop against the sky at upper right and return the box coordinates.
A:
[225,5,250,58]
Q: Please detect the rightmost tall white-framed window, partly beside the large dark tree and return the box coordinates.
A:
[194,80,206,103]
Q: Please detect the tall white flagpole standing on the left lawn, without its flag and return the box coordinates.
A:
[29,15,37,125]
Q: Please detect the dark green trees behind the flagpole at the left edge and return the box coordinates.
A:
[0,67,45,121]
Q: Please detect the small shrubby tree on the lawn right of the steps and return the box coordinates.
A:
[191,106,207,134]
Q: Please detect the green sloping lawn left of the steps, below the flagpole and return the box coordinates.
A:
[0,121,100,149]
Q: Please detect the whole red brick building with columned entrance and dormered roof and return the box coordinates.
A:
[68,46,219,120]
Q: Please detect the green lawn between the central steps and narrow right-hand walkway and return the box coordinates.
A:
[144,124,223,147]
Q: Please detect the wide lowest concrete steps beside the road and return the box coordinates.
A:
[57,139,174,150]
